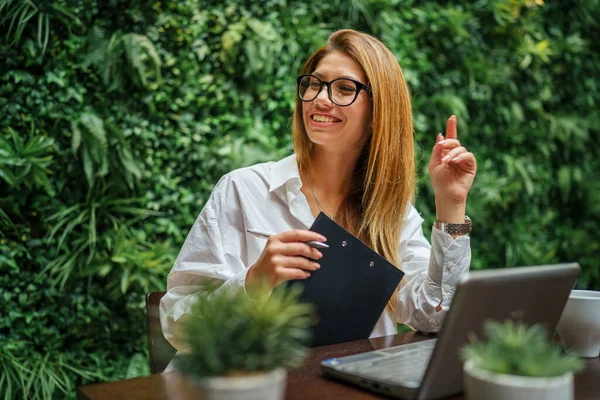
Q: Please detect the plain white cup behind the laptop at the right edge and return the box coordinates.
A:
[557,290,600,358]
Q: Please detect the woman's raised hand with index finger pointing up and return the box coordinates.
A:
[429,115,477,204]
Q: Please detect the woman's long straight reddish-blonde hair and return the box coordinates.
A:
[292,29,415,311]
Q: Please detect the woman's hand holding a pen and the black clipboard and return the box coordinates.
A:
[246,229,327,287]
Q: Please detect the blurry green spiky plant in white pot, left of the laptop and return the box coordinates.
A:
[174,287,314,400]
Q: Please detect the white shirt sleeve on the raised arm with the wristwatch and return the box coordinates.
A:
[397,206,471,332]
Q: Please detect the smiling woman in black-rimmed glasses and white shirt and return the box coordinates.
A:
[161,30,476,351]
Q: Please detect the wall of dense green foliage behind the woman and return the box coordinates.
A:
[0,0,600,398]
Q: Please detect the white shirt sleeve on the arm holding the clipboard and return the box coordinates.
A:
[160,176,248,352]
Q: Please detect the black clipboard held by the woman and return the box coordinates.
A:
[288,213,404,347]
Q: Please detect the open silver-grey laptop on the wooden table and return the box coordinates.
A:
[321,263,579,400]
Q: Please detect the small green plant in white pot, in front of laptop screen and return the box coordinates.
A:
[461,320,583,400]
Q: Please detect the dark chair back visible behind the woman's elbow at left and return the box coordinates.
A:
[146,292,176,374]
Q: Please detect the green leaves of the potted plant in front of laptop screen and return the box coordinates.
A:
[461,320,583,377]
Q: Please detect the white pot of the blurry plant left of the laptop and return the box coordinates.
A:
[195,368,287,400]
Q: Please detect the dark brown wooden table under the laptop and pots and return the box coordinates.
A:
[77,333,600,400]
